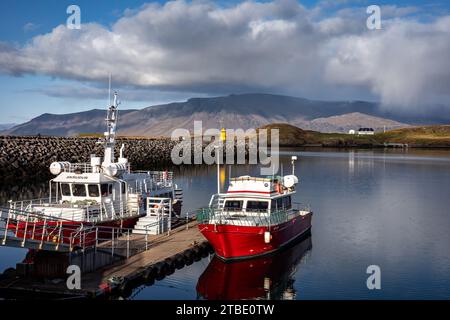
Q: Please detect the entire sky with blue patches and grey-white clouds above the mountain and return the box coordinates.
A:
[0,0,450,124]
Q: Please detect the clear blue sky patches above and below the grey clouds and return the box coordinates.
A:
[0,0,450,123]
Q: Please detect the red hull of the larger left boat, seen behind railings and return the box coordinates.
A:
[8,216,139,246]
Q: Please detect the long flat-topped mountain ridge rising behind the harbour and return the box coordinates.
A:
[7,94,407,136]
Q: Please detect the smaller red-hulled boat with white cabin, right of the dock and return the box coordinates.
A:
[197,157,312,260]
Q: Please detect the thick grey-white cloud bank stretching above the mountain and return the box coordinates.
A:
[0,0,450,113]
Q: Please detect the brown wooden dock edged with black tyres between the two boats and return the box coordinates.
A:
[0,221,212,298]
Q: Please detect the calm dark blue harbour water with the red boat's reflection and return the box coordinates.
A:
[0,150,450,299]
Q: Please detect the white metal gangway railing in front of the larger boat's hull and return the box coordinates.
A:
[0,208,152,257]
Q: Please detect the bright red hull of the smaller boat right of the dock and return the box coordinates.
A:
[199,213,312,260]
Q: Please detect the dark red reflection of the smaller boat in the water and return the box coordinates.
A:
[197,235,312,300]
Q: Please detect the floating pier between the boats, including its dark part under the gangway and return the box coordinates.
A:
[0,219,209,299]
